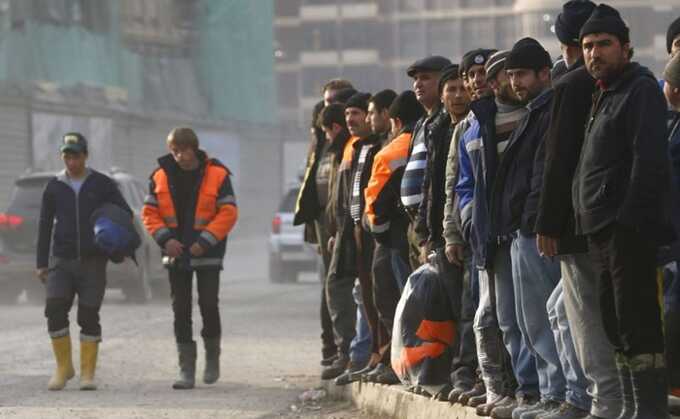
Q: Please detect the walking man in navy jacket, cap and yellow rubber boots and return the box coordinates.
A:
[37,132,132,390]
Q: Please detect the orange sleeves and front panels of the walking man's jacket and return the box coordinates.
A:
[142,159,238,254]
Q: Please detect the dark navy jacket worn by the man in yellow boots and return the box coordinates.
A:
[36,169,132,268]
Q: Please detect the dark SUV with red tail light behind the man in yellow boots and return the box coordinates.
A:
[0,169,169,303]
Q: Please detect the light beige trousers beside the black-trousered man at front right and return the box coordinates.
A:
[561,253,622,419]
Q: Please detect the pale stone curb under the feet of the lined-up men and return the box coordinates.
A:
[321,381,481,419]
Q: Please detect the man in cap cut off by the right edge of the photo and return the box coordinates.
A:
[663,54,680,414]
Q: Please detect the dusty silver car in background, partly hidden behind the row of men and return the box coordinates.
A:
[269,186,321,282]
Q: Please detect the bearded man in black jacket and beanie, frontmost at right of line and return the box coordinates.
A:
[573,4,672,418]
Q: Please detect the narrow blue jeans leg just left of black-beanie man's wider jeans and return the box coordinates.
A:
[493,243,540,395]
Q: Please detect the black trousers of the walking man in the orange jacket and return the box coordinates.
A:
[169,268,222,343]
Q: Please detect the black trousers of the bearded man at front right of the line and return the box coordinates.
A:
[588,222,664,356]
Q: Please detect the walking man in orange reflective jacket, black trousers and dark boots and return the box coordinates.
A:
[142,128,238,390]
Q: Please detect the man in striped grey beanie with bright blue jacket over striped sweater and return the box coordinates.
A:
[455,44,539,418]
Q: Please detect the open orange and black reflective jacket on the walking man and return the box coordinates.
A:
[142,150,238,270]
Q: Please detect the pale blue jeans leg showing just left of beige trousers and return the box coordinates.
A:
[546,281,592,412]
